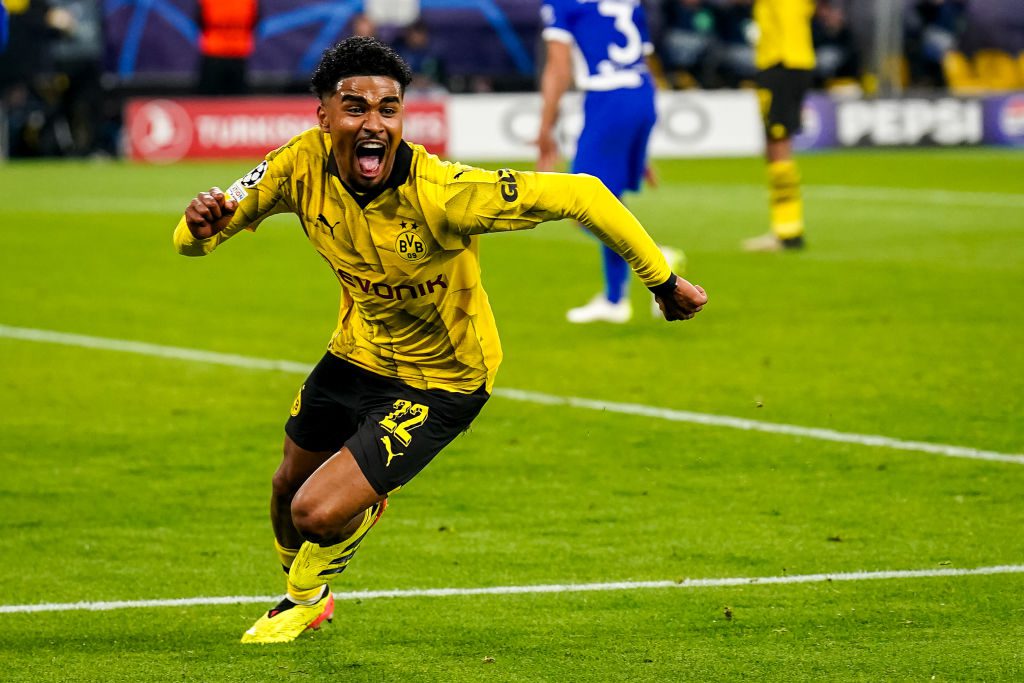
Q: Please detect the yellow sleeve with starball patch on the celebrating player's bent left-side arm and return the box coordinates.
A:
[174,140,295,256]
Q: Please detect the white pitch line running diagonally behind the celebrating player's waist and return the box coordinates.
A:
[0,325,1024,465]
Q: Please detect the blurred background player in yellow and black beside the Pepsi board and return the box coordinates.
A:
[743,0,814,251]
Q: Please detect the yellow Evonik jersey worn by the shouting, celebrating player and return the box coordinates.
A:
[174,128,671,393]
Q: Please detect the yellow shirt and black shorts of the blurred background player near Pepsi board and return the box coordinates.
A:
[754,0,814,139]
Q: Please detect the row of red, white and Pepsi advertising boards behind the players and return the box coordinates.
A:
[125,90,1024,164]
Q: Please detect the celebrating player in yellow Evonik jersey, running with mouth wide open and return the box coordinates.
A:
[174,37,708,643]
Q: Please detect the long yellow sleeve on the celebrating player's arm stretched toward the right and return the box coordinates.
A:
[444,165,672,287]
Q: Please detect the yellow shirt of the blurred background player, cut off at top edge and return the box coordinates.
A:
[754,0,814,69]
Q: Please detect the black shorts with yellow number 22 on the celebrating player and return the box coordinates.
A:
[285,353,490,496]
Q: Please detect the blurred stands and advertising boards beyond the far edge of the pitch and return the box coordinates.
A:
[0,0,1024,162]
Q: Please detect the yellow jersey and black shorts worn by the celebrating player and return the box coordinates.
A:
[174,128,673,495]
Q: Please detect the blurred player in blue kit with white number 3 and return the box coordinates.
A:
[537,0,682,323]
